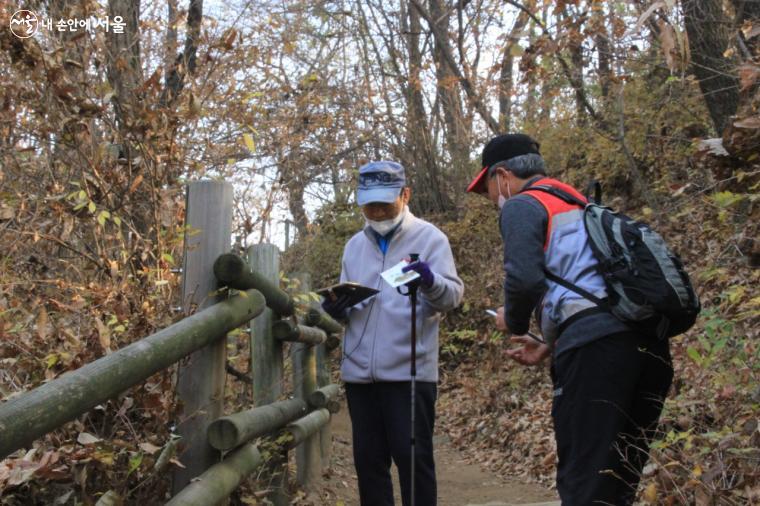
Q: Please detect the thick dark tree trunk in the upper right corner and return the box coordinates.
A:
[681,0,739,135]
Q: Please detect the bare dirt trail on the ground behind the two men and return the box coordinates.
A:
[310,404,559,506]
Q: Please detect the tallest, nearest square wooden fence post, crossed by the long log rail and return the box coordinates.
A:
[172,181,233,495]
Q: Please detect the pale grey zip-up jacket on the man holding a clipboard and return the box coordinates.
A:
[340,211,464,383]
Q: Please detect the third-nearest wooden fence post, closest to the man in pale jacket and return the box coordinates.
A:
[291,272,322,490]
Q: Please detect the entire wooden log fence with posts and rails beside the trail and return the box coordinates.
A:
[0,181,343,506]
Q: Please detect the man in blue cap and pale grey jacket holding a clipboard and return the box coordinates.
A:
[323,161,464,506]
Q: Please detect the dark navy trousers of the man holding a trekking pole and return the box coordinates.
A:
[346,381,437,506]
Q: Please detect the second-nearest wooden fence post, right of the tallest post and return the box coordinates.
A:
[248,244,290,506]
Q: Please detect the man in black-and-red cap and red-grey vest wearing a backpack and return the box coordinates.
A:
[467,134,699,505]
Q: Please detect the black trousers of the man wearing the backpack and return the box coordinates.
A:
[552,333,673,506]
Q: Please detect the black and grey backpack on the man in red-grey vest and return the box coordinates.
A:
[523,182,701,338]
